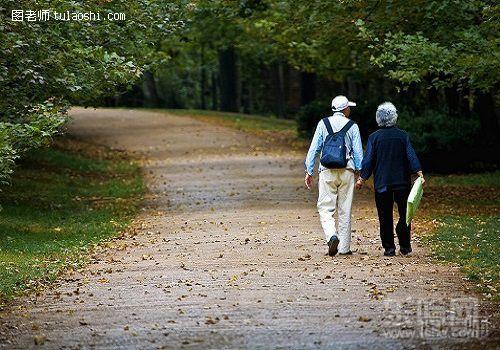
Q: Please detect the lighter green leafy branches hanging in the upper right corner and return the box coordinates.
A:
[356,0,500,91]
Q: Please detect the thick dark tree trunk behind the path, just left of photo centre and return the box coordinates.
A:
[219,47,238,112]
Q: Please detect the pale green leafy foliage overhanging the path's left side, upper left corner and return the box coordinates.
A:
[0,0,181,186]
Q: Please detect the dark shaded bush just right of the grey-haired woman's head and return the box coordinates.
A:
[398,109,479,154]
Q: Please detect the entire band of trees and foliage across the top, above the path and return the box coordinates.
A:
[0,0,500,180]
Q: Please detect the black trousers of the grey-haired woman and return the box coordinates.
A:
[375,189,411,250]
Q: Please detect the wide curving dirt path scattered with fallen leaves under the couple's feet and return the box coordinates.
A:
[0,109,497,349]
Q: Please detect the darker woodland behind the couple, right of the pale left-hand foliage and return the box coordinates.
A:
[119,0,500,168]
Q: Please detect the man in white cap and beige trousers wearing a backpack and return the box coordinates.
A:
[305,96,363,256]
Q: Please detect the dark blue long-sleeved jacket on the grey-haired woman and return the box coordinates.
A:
[361,127,422,192]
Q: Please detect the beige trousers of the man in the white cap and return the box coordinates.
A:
[318,169,354,253]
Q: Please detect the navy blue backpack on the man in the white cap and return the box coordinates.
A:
[319,117,354,169]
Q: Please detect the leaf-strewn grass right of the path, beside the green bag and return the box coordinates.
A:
[424,171,500,302]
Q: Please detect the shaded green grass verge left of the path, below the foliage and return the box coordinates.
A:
[0,140,144,304]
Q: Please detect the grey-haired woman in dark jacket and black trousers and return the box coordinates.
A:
[356,102,424,256]
